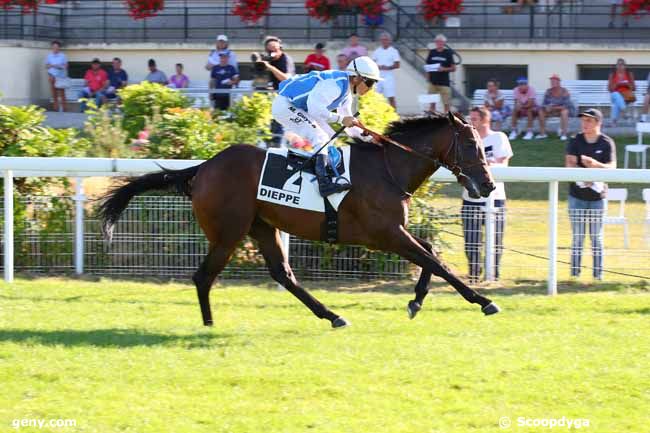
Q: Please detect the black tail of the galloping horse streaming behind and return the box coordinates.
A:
[99,164,201,242]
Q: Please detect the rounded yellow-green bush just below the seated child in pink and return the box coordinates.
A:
[118,81,191,138]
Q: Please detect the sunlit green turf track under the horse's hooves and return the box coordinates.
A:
[0,278,650,433]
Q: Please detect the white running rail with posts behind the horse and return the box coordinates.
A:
[0,157,650,295]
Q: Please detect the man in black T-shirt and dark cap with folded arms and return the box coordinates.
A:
[565,108,616,280]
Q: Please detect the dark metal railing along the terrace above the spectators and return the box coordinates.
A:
[0,0,650,47]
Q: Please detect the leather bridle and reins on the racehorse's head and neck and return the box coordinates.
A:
[359,120,480,197]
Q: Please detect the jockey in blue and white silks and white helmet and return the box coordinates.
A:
[272,56,381,197]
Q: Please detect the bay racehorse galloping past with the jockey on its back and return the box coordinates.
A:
[99,113,500,328]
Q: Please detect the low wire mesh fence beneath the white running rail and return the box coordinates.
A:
[1,185,650,284]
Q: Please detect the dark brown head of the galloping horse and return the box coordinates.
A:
[438,112,496,198]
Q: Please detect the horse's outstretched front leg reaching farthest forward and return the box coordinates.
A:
[390,227,500,315]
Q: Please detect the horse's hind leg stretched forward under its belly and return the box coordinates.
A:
[249,219,349,328]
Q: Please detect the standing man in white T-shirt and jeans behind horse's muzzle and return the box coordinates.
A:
[461,107,512,283]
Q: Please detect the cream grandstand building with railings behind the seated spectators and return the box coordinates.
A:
[0,0,650,114]
